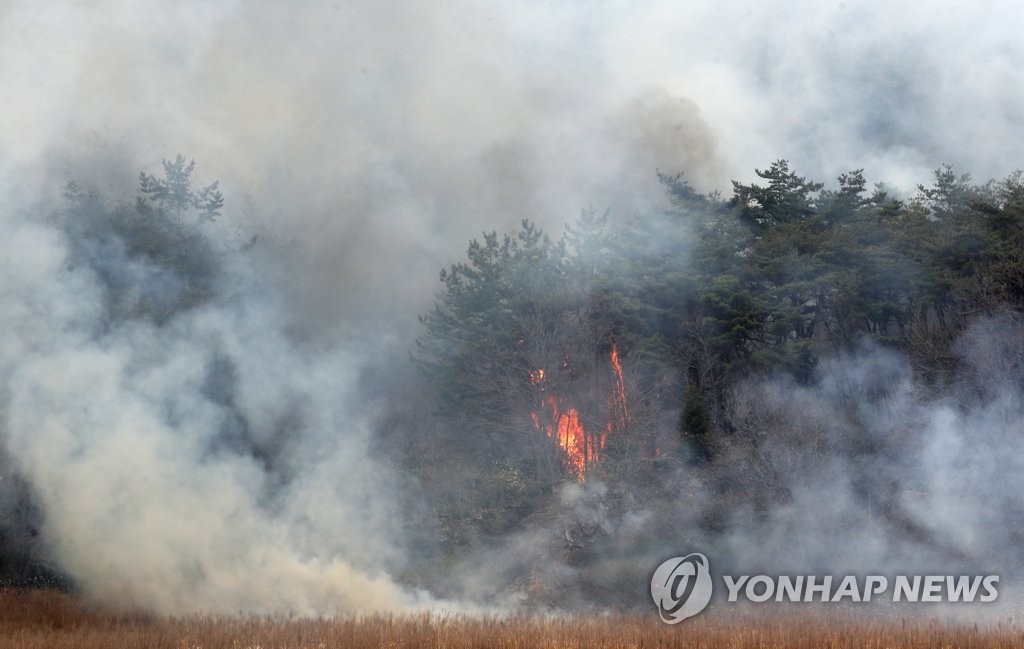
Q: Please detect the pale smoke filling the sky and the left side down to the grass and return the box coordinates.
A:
[0,0,1024,612]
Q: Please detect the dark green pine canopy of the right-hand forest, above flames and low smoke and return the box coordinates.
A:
[420,160,1024,481]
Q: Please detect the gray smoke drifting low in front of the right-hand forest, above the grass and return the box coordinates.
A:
[421,312,1024,620]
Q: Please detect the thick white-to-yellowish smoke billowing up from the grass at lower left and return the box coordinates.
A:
[0,183,432,613]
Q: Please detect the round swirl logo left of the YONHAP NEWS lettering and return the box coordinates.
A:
[650,553,712,624]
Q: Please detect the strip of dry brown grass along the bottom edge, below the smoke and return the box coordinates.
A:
[0,591,1024,649]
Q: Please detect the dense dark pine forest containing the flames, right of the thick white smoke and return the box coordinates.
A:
[407,160,1024,606]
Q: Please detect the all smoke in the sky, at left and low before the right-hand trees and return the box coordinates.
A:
[0,1,1024,613]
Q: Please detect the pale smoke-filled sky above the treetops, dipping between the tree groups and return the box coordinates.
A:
[0,1,1024,331]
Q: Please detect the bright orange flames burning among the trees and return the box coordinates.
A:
[529,340,629,480]
